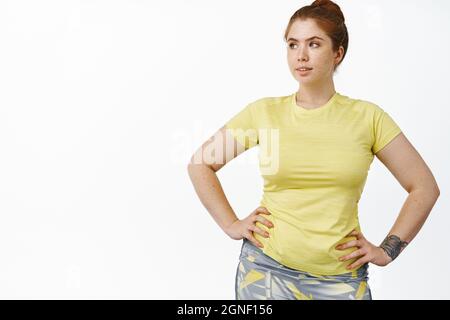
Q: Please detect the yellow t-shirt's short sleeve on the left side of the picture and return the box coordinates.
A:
[225,103,259,149]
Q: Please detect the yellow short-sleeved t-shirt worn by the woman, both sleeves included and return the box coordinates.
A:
[226,92,401,275]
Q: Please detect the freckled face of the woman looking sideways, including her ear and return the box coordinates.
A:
[287,19,344,86]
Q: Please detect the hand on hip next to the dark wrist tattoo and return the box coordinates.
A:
[336,230,392,270]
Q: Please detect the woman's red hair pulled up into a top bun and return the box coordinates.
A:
[284,0,348,70]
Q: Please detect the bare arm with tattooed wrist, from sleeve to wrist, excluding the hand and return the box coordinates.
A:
[376,133,440,260]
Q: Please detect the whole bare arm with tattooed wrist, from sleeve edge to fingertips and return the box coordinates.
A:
[336,133,440,269]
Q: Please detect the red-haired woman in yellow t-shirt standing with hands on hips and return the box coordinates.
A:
[188,1,440,300]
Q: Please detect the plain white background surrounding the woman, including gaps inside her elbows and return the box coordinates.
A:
[0,0,450,299]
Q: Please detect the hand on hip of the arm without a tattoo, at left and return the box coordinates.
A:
[225,207,274,248]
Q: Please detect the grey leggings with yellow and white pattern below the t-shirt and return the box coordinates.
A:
[235,238,372,300]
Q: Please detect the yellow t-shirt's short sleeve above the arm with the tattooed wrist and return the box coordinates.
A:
[372,107,402,154]
